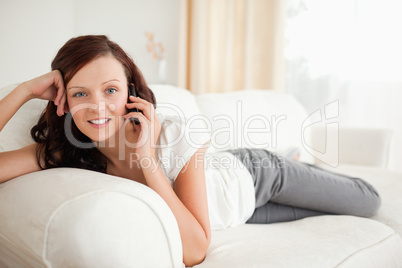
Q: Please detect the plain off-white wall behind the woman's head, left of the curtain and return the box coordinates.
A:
[0,0,180,87]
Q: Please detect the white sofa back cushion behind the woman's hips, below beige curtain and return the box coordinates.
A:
[196,89,313,163]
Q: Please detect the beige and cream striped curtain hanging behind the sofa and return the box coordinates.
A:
[179,0,286,94]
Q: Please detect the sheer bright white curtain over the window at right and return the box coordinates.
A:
[285,0,402,171]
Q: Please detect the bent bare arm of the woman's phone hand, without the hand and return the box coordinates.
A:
[143,148,211,266]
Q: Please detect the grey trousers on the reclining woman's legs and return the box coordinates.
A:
[226,148,381,223]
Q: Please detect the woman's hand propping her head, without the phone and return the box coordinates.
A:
[24,70,68,116]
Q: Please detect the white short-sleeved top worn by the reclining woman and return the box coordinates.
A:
[156,117,255,230]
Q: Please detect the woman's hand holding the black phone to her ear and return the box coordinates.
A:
[124,96,161,162]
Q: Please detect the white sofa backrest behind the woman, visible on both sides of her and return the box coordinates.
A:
[0,85,312,162]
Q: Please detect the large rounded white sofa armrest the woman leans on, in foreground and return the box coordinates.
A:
[0,168,184,267]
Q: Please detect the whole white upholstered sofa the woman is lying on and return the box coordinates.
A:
[0,85,402,268]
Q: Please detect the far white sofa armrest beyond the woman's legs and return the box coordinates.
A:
[311,127,392,168]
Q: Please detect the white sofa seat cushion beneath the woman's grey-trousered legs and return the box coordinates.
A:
[194,216,402,268]
